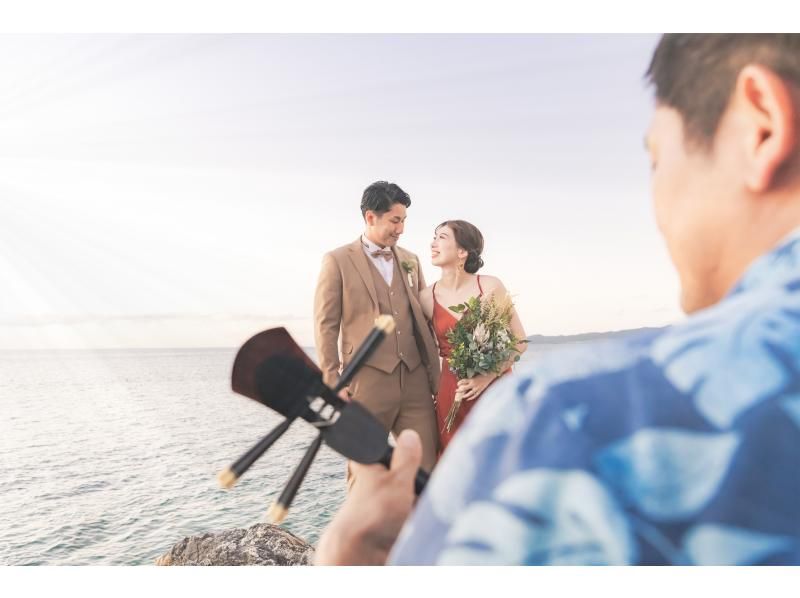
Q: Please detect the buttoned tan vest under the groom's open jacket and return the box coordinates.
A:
[366,259,422,374]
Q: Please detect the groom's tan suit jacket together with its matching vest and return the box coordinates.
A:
[314,237,440,396]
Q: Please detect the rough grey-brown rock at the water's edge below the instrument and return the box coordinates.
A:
[156,523,314,565]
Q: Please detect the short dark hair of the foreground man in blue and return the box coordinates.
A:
[646,33,800,147]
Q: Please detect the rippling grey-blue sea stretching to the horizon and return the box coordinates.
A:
[0,346,568,565]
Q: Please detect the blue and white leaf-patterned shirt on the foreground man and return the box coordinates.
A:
[390,230,800,565]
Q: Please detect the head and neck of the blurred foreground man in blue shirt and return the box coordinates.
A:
[647,33,800,313]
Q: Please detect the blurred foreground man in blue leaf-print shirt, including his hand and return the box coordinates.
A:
[316,34,800,565]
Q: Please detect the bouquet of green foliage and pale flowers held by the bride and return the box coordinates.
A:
[445,295,524,432]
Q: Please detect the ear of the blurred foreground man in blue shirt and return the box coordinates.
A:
[732,64,798,193]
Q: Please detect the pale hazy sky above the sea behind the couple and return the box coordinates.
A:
[0,34,682,350]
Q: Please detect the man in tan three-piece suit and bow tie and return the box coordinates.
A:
[314,181,439,471]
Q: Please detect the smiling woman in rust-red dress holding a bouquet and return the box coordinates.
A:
[420,220,527,451]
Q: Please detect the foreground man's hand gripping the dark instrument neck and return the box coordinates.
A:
[314,430,422,565]
